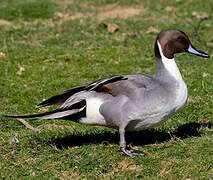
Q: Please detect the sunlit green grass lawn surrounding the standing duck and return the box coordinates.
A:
[0,0,213,179]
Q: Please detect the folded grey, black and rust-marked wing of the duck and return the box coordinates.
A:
[38,74,153,106]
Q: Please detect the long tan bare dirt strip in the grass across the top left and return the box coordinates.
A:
[0,3,146,29]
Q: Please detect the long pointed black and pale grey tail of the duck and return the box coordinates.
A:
[3,100,86,121]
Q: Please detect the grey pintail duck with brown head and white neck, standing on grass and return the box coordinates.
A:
[4,29,210,156]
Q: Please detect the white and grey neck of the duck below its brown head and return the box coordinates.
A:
[155,41,183,81]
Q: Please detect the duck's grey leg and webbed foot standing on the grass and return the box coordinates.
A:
[119,128,145,156]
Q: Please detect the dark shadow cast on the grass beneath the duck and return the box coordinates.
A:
[50,122,213,149]
